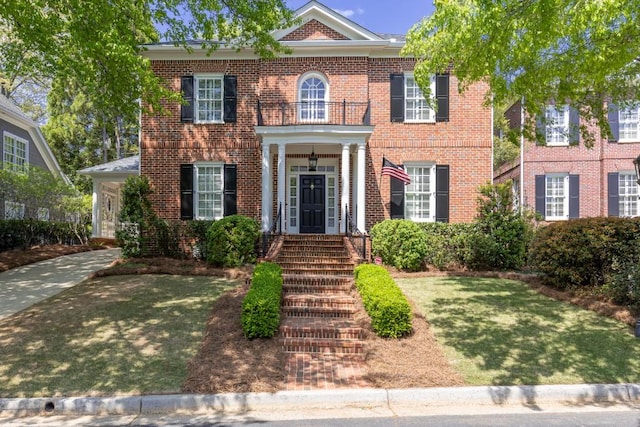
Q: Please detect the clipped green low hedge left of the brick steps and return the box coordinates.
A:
[241,262,282,339]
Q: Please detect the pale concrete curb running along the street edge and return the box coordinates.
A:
[0,384,640,417]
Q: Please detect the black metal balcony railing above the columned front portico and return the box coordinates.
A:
[257,100,371,126]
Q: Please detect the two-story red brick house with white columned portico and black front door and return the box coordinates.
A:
[140,1,492,241]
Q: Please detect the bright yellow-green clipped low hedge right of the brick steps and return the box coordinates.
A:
[354,264,413,338]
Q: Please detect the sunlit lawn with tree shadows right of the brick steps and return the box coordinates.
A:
[396,277,640,385]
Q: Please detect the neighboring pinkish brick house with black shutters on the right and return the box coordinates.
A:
[495,102,640,221]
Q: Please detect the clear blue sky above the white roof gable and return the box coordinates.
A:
[286,0,434,34]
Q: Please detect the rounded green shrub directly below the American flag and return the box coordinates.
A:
[370,219,427,271]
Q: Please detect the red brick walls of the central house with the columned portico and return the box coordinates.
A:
[141,3,492,230]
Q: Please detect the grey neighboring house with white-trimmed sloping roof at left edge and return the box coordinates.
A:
[0,93,70,220]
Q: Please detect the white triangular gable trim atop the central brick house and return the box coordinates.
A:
[272,0,382,40]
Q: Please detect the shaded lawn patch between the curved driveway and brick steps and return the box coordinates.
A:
[0,275,239,398]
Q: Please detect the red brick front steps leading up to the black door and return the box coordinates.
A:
[274,235,368,390]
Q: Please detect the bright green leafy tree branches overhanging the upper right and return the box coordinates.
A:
[403,0,640,146]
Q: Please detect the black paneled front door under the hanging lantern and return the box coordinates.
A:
[300,175,325,234]
